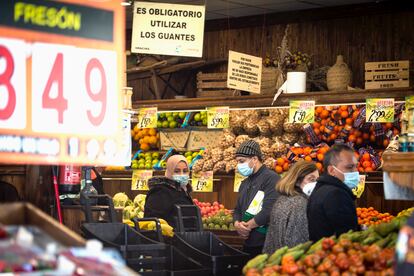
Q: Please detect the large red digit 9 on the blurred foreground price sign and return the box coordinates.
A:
[85,58,106,126]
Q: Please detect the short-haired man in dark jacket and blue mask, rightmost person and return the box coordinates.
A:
[307,144,359,241]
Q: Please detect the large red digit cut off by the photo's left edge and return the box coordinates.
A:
[0,45,16,120]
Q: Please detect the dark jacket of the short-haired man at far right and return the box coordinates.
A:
[307,175,359,241]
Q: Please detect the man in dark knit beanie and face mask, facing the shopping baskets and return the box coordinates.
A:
[233,140,280,258]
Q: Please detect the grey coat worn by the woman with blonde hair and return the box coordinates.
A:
[263,194,309,254]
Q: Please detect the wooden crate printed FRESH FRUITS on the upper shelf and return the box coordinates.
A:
[365,60,410,89]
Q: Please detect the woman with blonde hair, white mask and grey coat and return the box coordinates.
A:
[263,161,319,254]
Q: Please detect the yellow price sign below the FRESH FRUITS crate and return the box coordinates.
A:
[366,99,395,123]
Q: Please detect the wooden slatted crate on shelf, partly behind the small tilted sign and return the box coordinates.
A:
[197,72,240,98]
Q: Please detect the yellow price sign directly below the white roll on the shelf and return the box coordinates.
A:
[289,101,315,124]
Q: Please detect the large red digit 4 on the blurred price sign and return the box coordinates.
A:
[42,53,68,124]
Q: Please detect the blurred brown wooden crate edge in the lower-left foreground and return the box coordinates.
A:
[0,202,85,246]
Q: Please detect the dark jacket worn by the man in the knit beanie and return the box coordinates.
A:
[233,166,280,247]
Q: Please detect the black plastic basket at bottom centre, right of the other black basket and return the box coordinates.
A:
[171,232,249,275]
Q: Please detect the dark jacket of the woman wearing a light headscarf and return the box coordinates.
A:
[144,177,193,227]
